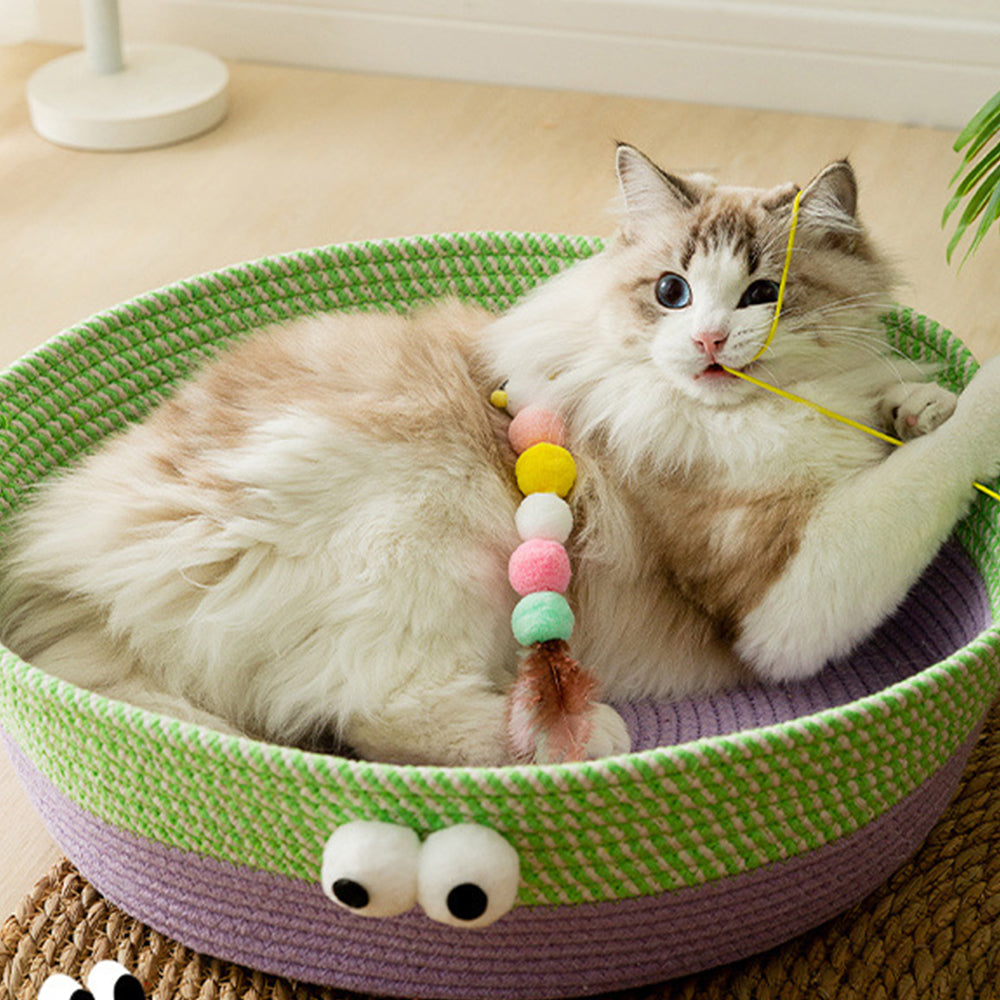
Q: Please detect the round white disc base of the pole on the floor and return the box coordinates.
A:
[27,45,229,150]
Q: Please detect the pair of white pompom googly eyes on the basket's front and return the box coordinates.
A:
[320,820,521,928]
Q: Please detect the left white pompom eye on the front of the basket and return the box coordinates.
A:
[320,820,420,917]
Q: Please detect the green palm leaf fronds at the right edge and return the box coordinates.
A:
[941,93,1000,263]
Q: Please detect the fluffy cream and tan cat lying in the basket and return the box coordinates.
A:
[0,144,1000,766]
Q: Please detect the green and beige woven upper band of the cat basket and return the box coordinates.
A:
[0,233,1000,905]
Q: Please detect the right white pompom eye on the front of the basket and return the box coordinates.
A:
[417,823,521,927]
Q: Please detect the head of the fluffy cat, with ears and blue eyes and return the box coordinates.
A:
[611,146,890,405]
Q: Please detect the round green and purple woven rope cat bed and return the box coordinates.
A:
[0,234,1000,1000]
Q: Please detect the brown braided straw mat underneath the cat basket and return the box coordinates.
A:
[0,706,1000,1000]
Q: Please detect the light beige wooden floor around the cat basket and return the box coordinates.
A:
[0,45,1000,918]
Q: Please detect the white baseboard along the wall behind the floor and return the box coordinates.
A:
[29,0,1000,128]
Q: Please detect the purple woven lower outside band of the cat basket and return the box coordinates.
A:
[4,734,975,1000]
